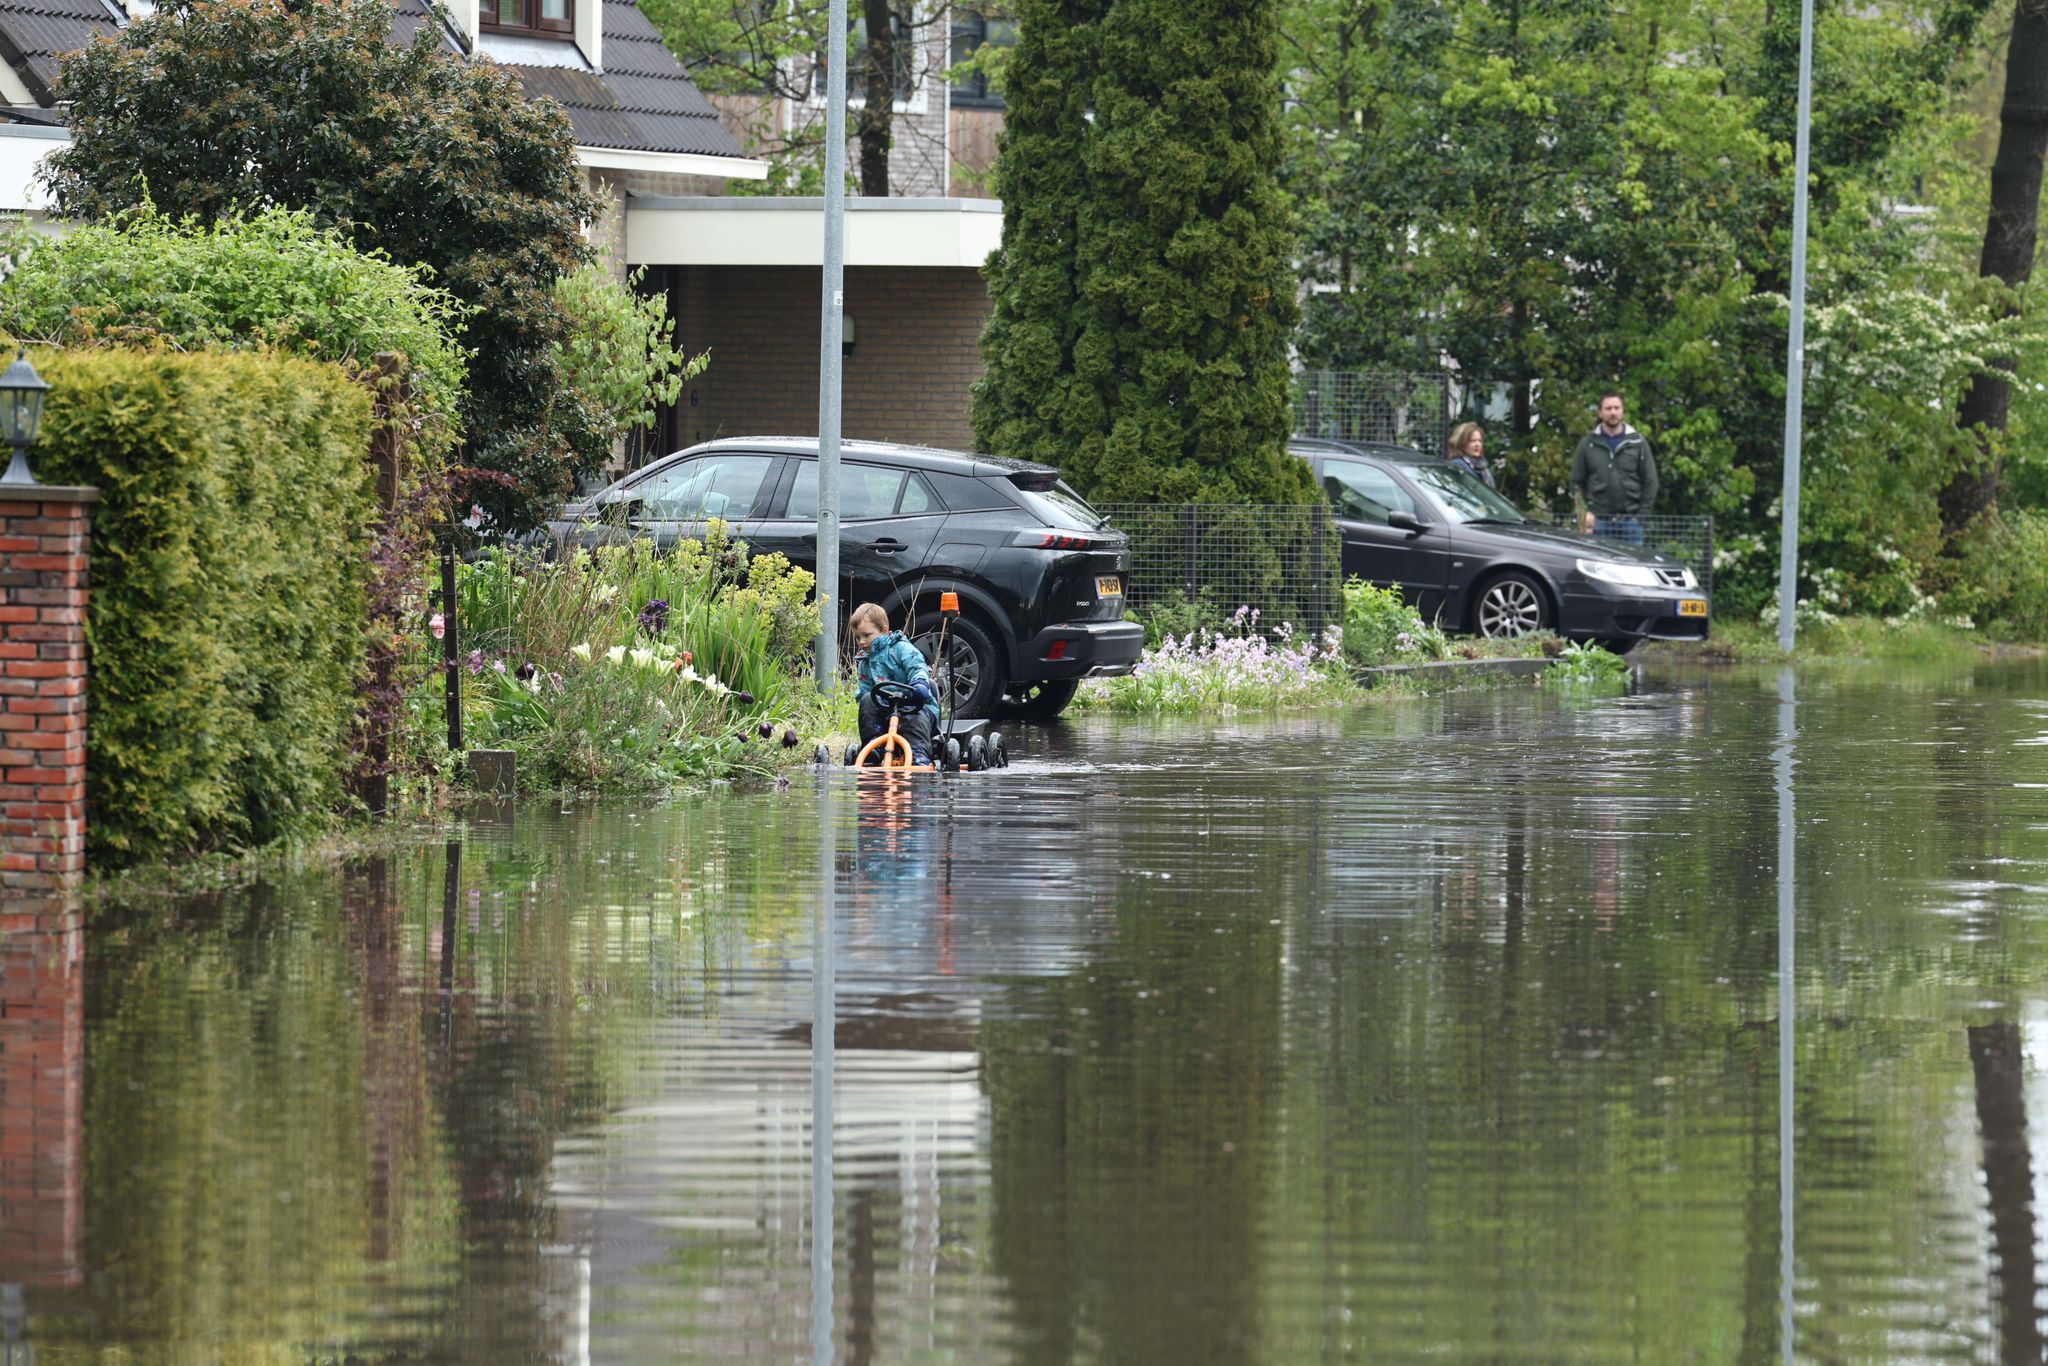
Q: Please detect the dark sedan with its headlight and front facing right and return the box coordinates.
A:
[1292,438,1708,651]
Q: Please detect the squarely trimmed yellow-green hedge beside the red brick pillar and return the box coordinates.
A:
[33,350,373,866]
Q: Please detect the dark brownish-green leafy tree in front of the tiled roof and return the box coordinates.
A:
[49,0,608,524]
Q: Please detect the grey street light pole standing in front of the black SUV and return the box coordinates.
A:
[817,0,846,692]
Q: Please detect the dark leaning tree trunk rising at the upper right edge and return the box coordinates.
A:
[1942,0,2048,535]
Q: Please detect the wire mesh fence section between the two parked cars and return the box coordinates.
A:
[1096,504,1343,631]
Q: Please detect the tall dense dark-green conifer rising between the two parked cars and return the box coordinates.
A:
[973,0,1313,502]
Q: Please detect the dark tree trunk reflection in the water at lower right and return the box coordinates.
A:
[1968,1019,2042,1362]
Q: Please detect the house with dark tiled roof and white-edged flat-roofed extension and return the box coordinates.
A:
[0,0,1001,455]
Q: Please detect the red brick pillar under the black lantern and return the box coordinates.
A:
[0,485,98,895]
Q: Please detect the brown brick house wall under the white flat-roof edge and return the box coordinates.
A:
[649,266,989,453]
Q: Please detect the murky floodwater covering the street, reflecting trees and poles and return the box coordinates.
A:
[12,661,2048,1366]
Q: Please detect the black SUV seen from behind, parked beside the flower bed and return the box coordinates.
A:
[547,436,1145,721]
